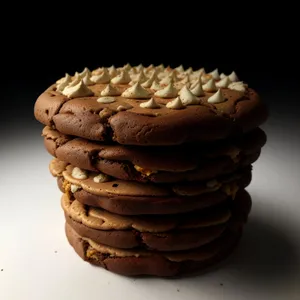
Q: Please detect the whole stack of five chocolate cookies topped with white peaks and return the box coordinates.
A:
[34,64,267,276]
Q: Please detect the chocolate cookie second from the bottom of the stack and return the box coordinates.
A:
[61,191,251,251]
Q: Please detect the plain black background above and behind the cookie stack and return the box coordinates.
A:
[0,7,300,132]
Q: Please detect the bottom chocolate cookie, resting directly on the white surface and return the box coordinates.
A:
[65,224,241,277]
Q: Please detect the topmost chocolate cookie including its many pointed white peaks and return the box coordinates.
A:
[34,65,267,146]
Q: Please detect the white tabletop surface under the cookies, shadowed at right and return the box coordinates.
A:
[0,120,300,300]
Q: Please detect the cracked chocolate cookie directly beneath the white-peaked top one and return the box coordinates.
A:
[43,127,266,182]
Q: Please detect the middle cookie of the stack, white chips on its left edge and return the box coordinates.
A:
[50,159,251,215]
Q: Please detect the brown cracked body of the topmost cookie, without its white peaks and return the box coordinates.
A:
[34,80,268,146]
